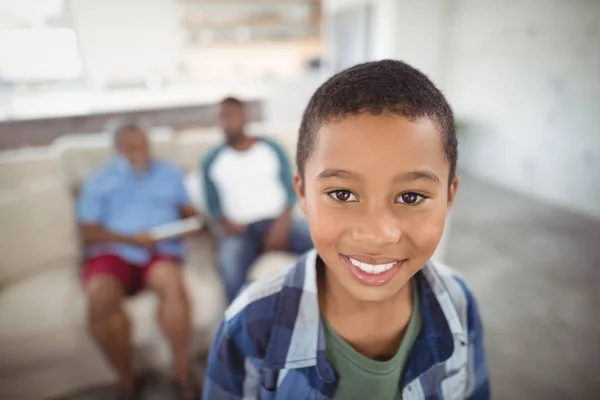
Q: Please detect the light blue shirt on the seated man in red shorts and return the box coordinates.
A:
[77,156,190,265]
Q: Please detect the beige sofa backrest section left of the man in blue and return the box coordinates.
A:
[0,147,80,285]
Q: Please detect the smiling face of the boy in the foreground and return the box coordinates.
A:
[295,114,458,301]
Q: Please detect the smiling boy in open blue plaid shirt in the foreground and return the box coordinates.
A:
[204,60,489,399]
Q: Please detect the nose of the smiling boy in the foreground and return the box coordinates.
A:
[353,212,402,247]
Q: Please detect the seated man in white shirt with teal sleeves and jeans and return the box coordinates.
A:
[202,97,312,301]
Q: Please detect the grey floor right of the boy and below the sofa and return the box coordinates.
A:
[62,177,600,400]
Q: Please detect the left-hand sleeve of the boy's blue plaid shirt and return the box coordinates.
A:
[202,321,254,400]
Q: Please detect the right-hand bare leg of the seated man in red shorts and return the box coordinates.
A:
[146,261,191,385]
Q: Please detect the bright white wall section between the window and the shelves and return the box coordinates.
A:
[69,0,182,86]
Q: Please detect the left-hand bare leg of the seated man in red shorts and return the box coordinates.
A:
[87,276,134,390]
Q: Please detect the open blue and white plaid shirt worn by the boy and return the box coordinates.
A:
[203,250,489,400]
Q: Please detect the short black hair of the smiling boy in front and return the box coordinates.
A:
[296,60,458,182]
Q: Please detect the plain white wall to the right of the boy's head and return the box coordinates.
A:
[448,0,600,218]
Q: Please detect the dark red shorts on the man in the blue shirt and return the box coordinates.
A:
[83,254,181,295]
